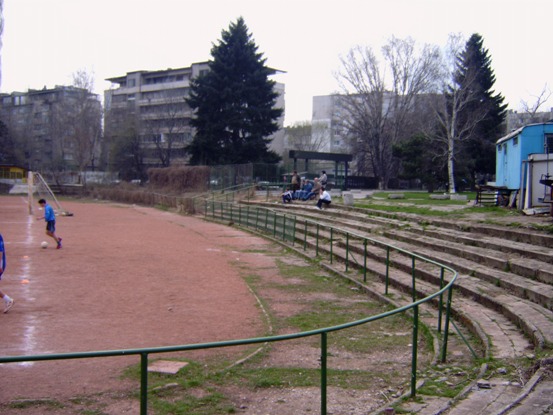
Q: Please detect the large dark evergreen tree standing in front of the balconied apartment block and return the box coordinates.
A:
[187,17,282,165]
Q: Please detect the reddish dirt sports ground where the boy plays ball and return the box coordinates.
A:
[0,196,272,413]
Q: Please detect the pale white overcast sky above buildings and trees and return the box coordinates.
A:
[0,0,553,125]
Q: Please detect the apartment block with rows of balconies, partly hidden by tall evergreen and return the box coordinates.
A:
[104,62,284,167]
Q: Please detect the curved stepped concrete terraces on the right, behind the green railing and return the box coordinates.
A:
[242,203,553,415]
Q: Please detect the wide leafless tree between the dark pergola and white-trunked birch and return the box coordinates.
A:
[337,37,440,188]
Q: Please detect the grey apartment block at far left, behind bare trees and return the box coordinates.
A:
[0,86,102,173]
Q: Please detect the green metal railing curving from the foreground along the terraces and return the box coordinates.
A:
[0,200,457,415]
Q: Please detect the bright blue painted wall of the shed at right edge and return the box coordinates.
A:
[495,123,553,189]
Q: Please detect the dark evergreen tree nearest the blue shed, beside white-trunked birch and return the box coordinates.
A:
[455,33,507,184]
